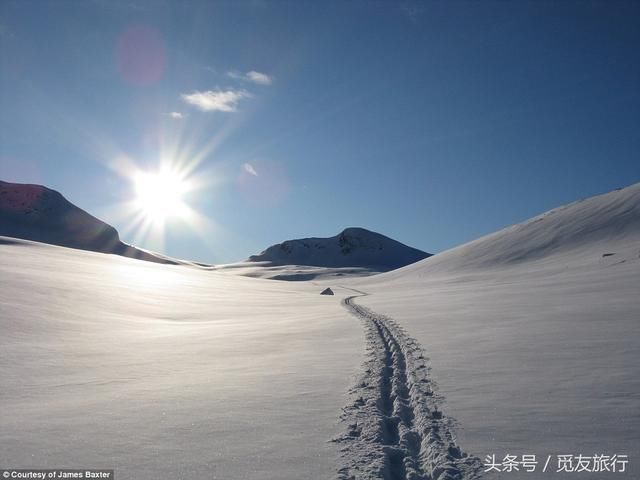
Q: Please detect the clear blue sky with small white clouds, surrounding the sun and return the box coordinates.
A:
[0,0,640,263]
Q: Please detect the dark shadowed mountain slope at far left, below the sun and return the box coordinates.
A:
[0,181,177,264]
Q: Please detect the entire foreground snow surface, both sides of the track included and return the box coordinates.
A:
[0,184,640,480]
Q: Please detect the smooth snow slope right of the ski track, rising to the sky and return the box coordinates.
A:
[350,184,640,480]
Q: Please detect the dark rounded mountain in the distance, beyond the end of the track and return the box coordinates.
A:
[248,228,430,272]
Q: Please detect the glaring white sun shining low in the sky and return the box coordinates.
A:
[134,169,189,222]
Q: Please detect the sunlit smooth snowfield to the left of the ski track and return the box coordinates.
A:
[0,238,364,480]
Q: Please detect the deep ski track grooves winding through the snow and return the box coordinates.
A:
[335,291,481,480]
